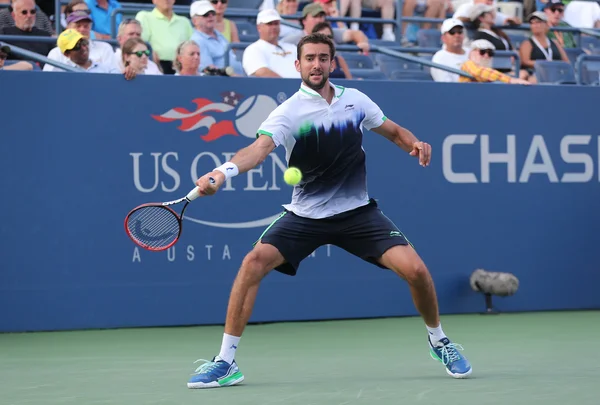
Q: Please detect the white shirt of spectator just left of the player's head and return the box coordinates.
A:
[242,39,300,79]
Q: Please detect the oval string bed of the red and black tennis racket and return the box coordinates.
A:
[127,206,180,249]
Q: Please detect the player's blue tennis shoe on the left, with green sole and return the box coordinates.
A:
[188,356,244,388]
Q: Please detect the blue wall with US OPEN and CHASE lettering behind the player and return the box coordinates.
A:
[0,72,600,331]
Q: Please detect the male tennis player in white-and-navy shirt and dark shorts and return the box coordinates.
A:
[188,34,472,388]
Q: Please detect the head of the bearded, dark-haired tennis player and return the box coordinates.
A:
[296,33,335,90]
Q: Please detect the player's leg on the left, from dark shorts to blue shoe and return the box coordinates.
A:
[188,212,324,388]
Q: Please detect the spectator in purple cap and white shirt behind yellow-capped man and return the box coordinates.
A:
[44,10,118,72]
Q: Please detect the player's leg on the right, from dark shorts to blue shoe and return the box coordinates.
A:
[336,201,471,378]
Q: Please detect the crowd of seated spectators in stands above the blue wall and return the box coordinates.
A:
[0,0,600,84]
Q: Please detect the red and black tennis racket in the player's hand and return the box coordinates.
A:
[125,177,215,252]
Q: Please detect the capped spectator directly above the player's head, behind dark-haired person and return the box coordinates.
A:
[282,3,369,53]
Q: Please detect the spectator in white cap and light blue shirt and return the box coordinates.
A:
[190,0,243,74]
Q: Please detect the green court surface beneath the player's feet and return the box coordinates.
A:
[0,311,600,405]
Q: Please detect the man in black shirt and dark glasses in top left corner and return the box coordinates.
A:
[0,0,52,60]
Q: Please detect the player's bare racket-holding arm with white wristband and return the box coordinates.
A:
[196,135,276,195]
